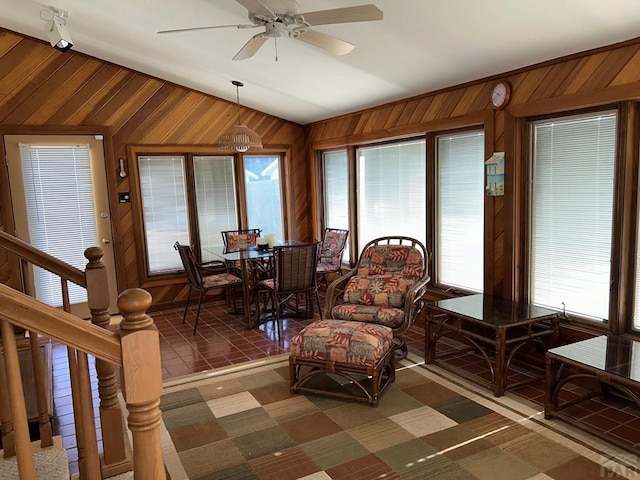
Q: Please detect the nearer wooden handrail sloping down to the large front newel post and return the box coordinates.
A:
[0,284,122,365]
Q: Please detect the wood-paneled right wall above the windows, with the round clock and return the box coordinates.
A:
[305,39,640,299]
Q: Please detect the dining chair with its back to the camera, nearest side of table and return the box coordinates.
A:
[258,243,322,341]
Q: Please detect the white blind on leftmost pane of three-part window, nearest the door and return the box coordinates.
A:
[138,156,190,274]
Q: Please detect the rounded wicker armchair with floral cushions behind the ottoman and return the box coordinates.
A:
[324,236,430,358]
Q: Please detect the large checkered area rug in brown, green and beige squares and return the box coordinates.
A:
[161,355,640,480]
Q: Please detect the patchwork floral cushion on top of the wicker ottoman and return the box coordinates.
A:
[290,320,393,367]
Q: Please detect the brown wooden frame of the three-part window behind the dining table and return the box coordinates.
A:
[127,145,290,287]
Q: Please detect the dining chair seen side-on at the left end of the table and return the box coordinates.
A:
[173,242,242,335]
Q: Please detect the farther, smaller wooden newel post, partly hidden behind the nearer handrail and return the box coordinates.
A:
[84,247,131,478]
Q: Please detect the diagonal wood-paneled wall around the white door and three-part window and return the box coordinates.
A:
[0,29,313,308]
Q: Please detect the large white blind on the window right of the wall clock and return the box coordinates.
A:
[529,113,616,320]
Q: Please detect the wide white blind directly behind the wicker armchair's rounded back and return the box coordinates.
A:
[356,140,427,250]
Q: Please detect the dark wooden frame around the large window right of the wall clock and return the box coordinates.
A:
[506,101,640,336]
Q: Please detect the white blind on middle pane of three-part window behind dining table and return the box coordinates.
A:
[193,156,238,261]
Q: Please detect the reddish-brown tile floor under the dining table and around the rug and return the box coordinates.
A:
[53,301,640,474]
